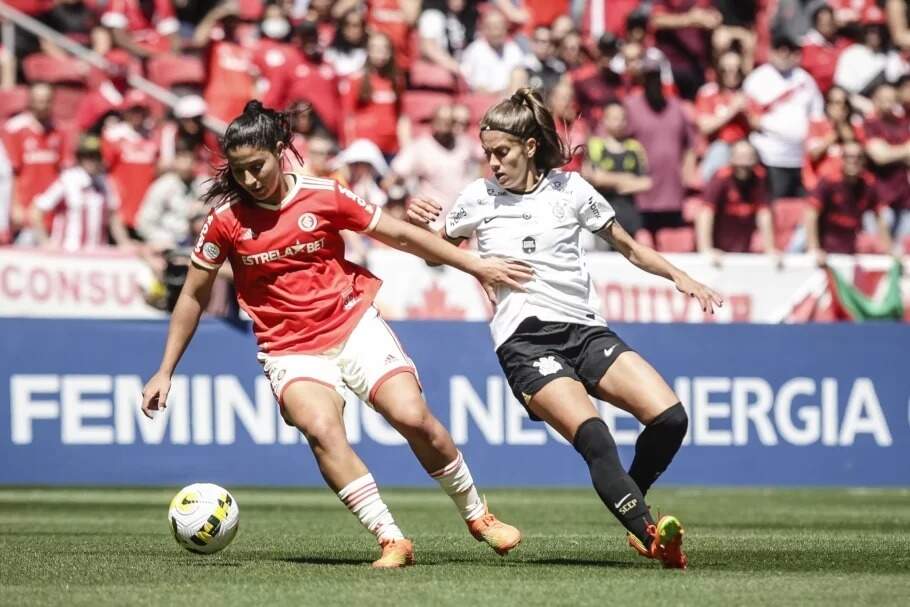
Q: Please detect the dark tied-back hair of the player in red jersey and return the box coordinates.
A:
[202,99,309,202]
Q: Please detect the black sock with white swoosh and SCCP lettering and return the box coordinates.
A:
[572,417,654,546]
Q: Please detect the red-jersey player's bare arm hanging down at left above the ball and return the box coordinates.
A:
[142,264,218,419]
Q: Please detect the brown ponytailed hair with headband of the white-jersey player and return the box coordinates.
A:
[480,88,572,173]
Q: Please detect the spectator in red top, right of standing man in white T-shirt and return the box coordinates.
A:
[803,86,864,190]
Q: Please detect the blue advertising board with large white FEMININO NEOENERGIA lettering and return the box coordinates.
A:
[0,318,910,485]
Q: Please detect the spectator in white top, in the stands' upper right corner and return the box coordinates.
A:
[834,6,910,104]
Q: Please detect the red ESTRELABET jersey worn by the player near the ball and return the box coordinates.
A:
[192,175,382,354]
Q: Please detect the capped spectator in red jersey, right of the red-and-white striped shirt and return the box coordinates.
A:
[101,91,159,234]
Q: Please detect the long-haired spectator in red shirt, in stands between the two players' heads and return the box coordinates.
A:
[341,33,407,157]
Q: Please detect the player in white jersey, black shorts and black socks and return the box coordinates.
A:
[408,89,722,568]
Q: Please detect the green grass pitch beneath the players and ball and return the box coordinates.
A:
[0,487,910,607]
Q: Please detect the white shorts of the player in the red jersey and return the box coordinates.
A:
[256,307,419,407]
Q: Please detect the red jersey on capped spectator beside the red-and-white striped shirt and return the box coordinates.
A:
[101,122,159,227]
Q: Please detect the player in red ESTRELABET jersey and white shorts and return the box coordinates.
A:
[142,101,530,568]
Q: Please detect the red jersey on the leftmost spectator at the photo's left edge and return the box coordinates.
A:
[3,112,64,209]
